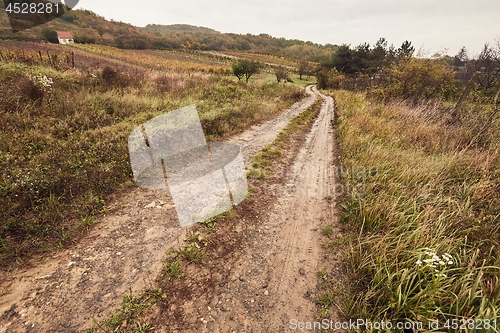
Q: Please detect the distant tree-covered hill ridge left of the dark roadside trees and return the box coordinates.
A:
[35,10,336,62]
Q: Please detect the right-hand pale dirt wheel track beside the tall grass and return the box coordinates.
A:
[179,87,336,333]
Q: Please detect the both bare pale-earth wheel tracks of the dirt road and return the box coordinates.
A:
[0,87,342,333]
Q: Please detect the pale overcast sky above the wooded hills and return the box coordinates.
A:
[76,0,500,55]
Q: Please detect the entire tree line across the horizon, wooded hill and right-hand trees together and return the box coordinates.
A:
[0,3,500,107]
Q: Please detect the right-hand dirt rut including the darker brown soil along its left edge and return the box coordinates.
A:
[160,90,340,333]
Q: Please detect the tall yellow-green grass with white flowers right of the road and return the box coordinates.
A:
[328,91,500,332]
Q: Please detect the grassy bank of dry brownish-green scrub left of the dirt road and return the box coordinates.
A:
[0,62,304,267]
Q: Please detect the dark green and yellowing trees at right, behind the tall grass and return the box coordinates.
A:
[316,38,500,107]
